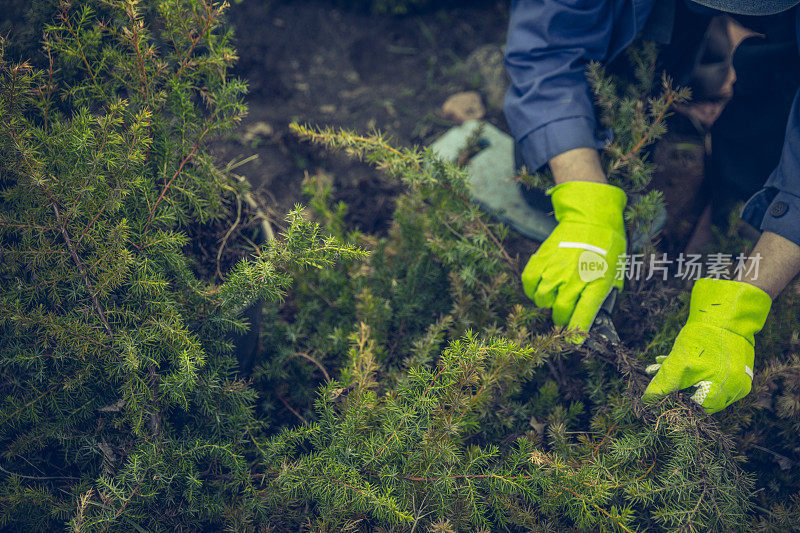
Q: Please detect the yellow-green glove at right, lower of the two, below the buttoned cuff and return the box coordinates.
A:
[643,279,772,414]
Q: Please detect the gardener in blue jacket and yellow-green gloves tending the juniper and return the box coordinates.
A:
[504,0,800,413]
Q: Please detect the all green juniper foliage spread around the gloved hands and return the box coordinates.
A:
[0,0,800,532]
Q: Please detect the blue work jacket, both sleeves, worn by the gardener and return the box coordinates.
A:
[505,0,800,245]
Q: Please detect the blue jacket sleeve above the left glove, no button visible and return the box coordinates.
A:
[504,0,652,170]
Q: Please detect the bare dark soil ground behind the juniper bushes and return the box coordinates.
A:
[214,0,703,260]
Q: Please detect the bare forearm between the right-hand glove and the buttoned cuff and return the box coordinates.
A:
[742,231,800,300]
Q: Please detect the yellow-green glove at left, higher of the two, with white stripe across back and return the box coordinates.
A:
[522,181,627,341]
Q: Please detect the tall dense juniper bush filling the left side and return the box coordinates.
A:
[0,0,360,531]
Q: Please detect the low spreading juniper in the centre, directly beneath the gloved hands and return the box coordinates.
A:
[261,118,752,531]
